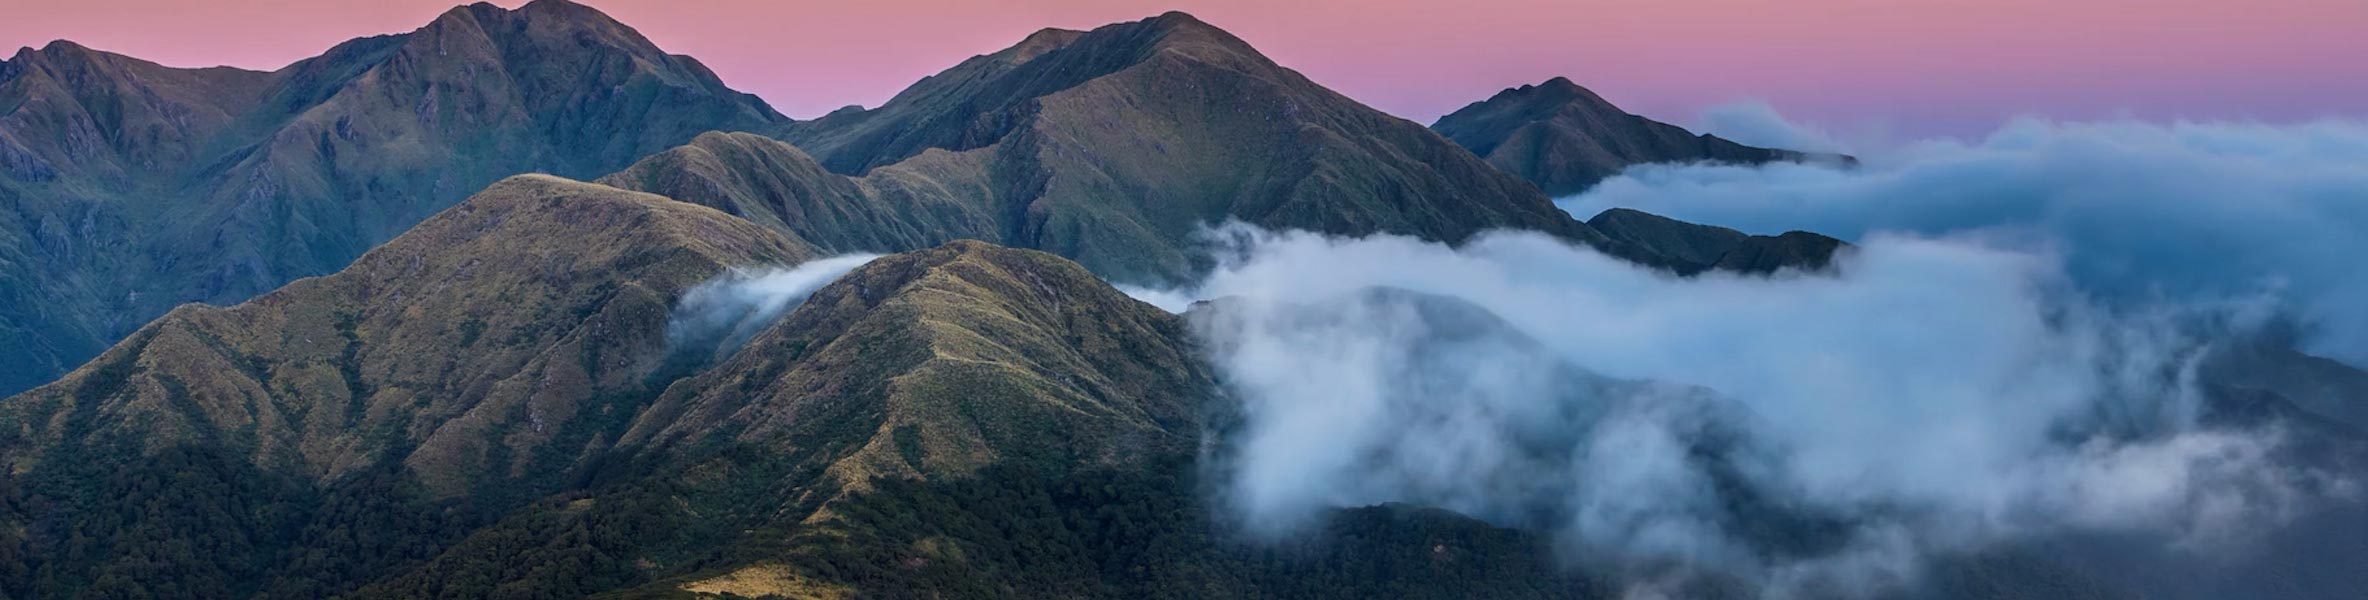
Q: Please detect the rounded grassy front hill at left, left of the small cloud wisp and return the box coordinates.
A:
[0,175,803,598]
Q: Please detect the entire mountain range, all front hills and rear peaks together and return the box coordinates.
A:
[0,0,2368,598]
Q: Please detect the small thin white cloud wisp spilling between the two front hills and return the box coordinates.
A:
[665,254,879,358]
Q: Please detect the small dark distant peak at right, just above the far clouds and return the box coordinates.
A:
[1430,78,1857,197]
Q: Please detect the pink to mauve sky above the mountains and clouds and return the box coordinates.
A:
[0,0,2368,135]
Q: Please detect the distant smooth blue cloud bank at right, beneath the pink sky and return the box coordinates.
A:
[1558,111,2368,365]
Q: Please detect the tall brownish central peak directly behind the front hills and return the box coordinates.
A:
[748,12,1603,280]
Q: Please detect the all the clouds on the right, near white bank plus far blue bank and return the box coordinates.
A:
[1130,111,2368,598]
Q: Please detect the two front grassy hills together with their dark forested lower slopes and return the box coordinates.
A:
[0,175,1589,598]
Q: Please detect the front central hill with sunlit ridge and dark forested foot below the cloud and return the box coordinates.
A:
[345,242,1589,598]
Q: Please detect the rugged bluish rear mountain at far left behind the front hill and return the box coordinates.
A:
[0,0,784,391]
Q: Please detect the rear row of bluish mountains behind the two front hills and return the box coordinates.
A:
[0,0,1847,400]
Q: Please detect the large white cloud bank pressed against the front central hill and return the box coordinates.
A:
[1136,225,2318,595]
